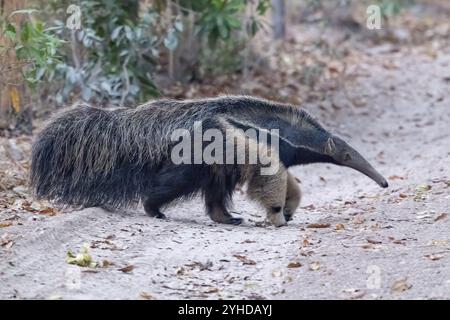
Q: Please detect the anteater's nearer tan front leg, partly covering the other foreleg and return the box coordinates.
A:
[247,168,287,227]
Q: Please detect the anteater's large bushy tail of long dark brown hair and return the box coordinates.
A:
[30,106,167,207]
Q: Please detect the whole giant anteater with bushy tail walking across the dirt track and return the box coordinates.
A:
[30,96,388,226]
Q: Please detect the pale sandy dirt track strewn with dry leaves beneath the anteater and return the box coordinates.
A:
[0,42,450,299]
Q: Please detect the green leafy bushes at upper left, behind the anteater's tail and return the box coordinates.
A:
[2,0,270,105]
